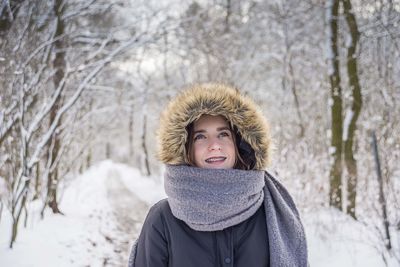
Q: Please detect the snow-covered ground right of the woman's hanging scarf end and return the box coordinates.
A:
[302,208,390,267]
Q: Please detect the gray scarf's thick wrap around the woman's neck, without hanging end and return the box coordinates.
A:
[164,165,264,231]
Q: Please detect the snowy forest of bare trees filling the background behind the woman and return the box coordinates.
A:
[0,0,400,265]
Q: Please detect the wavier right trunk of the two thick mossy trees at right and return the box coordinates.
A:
[342,0,362,219]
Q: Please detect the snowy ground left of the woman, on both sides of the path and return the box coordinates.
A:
[0,161,162,267]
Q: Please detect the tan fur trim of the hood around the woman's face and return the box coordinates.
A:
[158,83,271,170]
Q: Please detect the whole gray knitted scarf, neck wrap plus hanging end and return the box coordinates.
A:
[129,165,308,267]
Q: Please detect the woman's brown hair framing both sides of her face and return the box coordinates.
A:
[185,118,251,170]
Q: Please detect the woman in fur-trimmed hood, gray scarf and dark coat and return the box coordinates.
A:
[129,84,308,267]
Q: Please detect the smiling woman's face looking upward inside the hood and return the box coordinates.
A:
[192,115,236,169]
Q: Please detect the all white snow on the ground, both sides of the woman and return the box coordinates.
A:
[0,161,396,267]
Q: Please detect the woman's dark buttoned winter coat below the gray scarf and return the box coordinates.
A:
[134,199,269,267]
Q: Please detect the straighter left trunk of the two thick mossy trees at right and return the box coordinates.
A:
[327,0,343,210]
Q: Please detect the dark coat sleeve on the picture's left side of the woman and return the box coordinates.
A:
[128,203,168,267]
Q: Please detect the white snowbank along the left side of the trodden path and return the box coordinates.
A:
[0,160,119,267]
